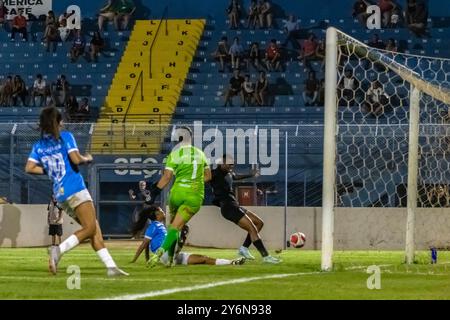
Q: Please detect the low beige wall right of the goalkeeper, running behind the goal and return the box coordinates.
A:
[188,206,450,250]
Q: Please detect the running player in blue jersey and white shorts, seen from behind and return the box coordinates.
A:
[25,107,128,276]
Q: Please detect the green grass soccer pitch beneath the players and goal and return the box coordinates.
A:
[0,241,450,300]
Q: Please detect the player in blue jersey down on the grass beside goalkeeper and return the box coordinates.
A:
[131,206,245,265]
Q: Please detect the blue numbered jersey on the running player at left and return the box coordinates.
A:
[28,131,86,203]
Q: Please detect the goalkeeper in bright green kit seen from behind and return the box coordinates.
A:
[149,126,211,267]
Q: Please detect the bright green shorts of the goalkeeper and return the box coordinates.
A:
[169,189,203,222]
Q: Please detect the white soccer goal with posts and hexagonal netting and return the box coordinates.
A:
[322,28,450,270]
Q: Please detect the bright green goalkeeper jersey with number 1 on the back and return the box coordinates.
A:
[166,145,208,198]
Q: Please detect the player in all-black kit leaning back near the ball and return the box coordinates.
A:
[210,155,281,264]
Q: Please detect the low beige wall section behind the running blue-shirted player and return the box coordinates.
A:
[0,204,79,248]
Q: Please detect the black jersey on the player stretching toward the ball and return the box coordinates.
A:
[210,167,237,206]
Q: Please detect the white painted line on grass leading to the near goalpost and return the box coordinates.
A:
[101,272,323,300]
